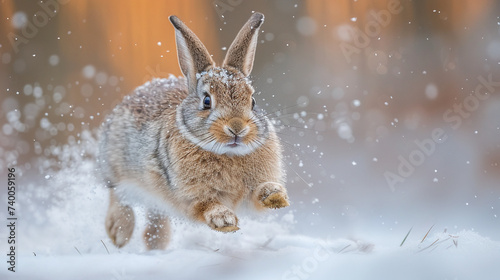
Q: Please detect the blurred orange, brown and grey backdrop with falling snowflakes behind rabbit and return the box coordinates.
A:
[0,0,500,240]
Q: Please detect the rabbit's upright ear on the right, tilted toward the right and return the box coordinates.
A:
[222,13,264,76]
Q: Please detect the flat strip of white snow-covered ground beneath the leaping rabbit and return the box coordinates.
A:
[9,230,500,280]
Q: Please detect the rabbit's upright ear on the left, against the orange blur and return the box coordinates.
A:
[169,16,214,93]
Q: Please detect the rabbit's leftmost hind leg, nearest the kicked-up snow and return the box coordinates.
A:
[105,188,135,248]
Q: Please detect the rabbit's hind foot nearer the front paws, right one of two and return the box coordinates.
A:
[143,211,170,250]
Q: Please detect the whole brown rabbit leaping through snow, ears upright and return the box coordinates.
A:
[98,12,290,250]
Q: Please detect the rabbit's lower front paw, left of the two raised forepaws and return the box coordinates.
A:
[204,205,240,232]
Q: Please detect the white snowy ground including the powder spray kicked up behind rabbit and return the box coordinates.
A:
[0,133,500,280]
